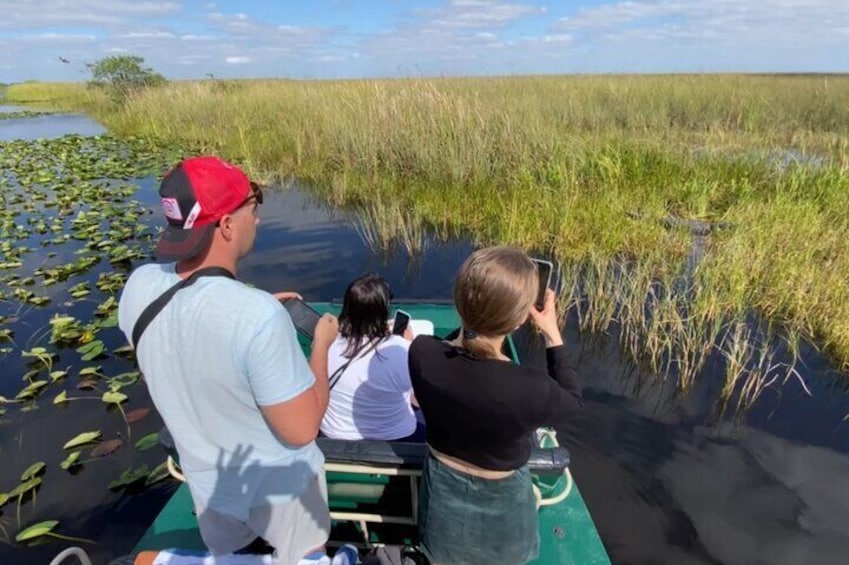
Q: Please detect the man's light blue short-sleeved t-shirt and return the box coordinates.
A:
[118,263,324,520]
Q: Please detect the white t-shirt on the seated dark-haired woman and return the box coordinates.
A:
[321,335,416,440]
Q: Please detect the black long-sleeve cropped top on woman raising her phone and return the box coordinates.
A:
[409,336,583,471]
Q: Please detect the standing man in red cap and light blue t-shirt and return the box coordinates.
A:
[118,157,338,564]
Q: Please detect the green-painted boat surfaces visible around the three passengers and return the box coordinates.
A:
[135,303,610,565]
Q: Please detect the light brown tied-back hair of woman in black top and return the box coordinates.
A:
[454,245,538,359]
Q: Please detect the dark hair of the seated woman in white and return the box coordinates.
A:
[339,273,392,358]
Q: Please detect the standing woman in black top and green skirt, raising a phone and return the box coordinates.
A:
[410,246,583,565]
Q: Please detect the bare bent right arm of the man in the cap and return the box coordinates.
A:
[260,314,339,446]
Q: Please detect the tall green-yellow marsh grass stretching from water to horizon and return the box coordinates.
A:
[9,75,849,410]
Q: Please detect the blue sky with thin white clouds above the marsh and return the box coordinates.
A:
[0,0,849,82]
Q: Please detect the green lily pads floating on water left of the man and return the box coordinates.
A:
[0,130,187,543]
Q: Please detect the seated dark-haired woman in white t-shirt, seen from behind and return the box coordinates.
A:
[321,274,424,441]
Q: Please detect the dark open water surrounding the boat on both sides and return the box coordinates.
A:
[0,114,849,564]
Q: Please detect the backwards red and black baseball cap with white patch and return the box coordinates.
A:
[154,156,262,260]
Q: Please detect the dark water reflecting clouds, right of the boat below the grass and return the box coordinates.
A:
[512,321,849,564]
